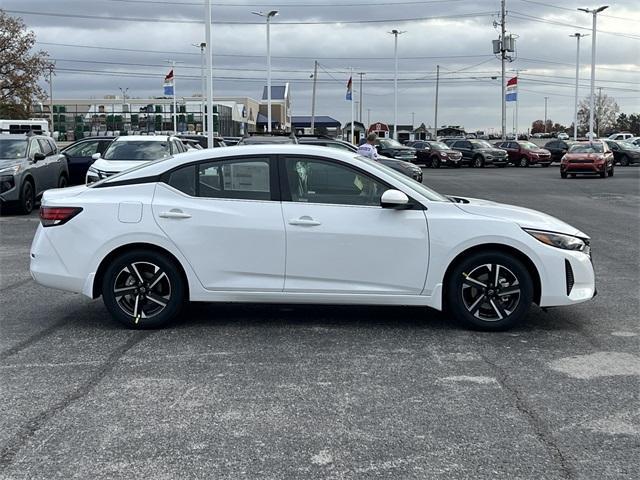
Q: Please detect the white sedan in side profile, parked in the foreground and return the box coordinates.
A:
[31,145,595,330]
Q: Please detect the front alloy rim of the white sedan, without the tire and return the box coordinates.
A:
[461,263,521,322]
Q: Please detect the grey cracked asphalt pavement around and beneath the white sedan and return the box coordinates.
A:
[0,166,640,479]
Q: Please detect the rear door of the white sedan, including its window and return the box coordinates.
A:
[152,155,285,292]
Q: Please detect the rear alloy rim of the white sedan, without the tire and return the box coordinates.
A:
[113,262,171,324]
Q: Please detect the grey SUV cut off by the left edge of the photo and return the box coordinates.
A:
[0,134,69,214]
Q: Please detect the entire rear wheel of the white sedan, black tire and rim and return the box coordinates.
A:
[102,250,186,329]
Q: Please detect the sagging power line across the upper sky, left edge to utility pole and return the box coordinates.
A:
[5,10,493,25]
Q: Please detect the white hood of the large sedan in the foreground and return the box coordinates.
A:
[456,197,589,238]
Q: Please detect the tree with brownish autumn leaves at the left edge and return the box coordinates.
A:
[0,10,51,118]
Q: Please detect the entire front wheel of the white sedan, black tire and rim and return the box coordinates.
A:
[445,251,533,331]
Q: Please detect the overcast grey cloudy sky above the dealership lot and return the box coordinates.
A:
[6,0,640,131]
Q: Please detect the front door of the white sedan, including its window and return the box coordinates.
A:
[279,155,429,295]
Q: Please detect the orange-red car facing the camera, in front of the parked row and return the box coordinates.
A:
[560,140,614,178]
